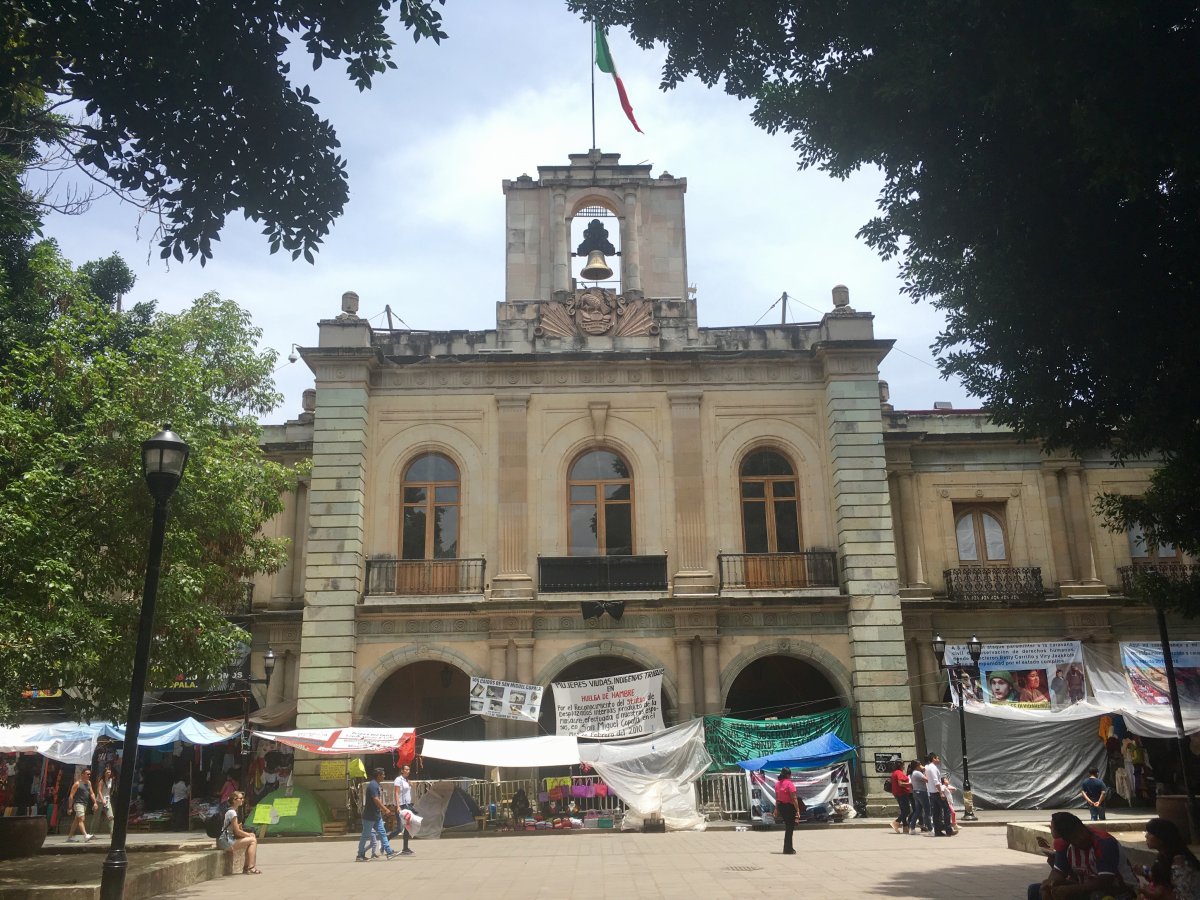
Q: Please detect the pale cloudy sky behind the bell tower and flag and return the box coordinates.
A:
[39,0,978,421]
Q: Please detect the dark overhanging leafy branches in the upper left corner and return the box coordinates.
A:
[0,0,445,263]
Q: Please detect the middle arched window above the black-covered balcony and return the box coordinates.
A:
[566,450,634,557]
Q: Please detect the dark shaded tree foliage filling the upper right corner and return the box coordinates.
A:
[568,0,1200,552]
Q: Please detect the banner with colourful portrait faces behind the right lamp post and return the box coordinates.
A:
[946,641,1087,709]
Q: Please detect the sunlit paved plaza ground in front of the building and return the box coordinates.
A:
[145,822,1045,900]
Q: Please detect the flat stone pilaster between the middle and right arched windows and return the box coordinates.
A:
[667,391,716,594]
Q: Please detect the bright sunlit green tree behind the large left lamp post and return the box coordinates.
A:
[0,266,296,720]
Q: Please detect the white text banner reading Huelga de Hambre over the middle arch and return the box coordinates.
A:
[552,668,664,738]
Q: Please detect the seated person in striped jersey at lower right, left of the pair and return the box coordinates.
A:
[1027,812,1133,900]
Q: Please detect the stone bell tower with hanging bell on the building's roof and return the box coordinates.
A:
[502,150,688,303]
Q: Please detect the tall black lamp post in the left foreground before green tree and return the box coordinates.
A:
[100,425,190,900]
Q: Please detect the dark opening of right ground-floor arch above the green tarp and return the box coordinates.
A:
[725,655,848,719]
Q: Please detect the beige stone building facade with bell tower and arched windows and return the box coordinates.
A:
[253,151,1190,811]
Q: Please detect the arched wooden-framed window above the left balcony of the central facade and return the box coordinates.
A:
[400,454,461,559]
